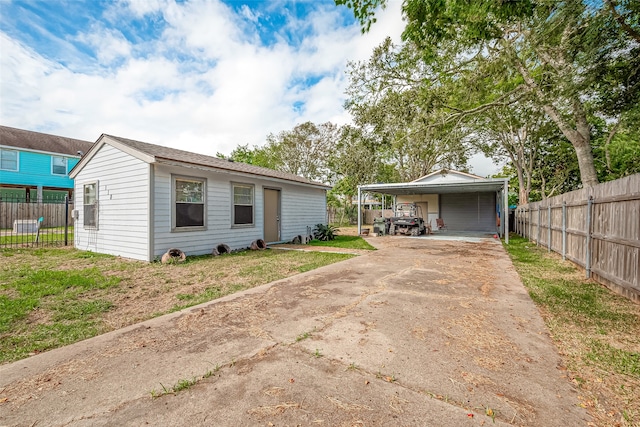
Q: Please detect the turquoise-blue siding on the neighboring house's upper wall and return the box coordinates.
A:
[0,151,80,188]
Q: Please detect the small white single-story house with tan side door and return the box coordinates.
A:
[70,134,330,261]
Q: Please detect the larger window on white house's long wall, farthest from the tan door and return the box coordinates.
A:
[173,178,206,228]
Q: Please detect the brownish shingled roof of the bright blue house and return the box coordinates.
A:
[0,126,93,157]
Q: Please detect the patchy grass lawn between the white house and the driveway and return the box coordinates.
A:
[0,248,353,363]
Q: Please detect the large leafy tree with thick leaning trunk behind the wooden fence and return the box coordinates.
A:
[336,0,638,186]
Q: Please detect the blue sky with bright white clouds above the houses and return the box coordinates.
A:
[0,0,496,176]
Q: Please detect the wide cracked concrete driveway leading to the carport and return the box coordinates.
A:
[0,237,589,427]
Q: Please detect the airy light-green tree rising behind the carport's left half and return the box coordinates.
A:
[346,39,467,181]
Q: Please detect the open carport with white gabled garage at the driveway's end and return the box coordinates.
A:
[358,170,509,239]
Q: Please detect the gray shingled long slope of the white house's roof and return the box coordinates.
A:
[98,134,331,188]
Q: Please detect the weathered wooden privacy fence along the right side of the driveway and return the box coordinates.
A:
[514,174,640,303]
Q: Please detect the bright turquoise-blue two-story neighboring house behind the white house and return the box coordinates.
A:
[0,126,93,202]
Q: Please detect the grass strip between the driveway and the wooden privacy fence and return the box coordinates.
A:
[504,235,640,427]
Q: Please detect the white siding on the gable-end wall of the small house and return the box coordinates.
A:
[74,145,149,260]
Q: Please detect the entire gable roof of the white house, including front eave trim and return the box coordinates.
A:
[69,134,331,189]
